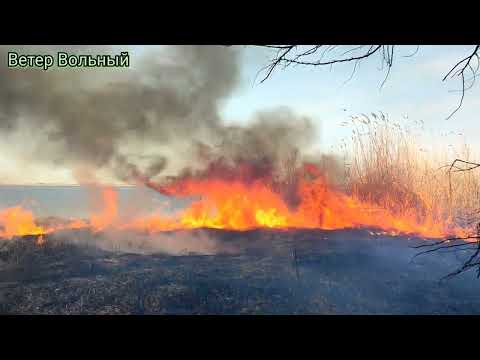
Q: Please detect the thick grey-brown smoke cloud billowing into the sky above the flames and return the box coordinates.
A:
[0,46,326,188]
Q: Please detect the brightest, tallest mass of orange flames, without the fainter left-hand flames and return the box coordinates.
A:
[125,172,465,238]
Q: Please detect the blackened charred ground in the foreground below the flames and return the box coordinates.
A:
[0,229,480,314]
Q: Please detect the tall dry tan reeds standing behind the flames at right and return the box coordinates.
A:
[343,114,480,236]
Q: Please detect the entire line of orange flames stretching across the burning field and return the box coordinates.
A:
[0,165,467,243]
